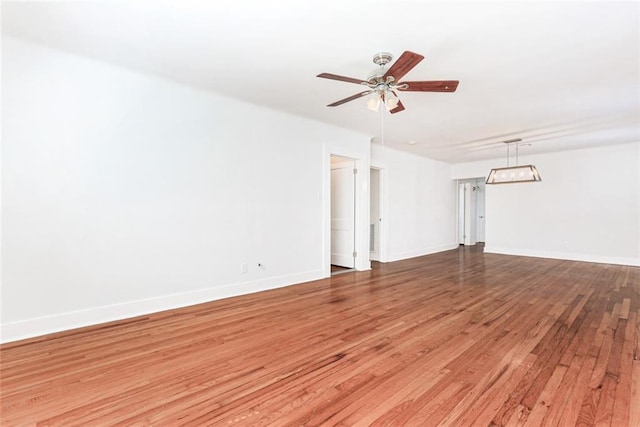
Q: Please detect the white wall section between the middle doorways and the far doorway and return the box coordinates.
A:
[371,144,458,261]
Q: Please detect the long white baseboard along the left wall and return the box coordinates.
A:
[0,270,323,343]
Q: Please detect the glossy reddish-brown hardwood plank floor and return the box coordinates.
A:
[0,248,640,427]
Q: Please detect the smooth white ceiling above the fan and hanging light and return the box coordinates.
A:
[2,0,640,162]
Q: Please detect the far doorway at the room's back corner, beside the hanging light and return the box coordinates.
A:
[458,178,486,246]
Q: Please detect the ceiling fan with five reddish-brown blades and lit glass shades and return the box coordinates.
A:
[316,50,459,114]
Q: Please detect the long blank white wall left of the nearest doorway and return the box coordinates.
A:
[1,38,369,341]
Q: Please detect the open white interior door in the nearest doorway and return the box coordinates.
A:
[331,161,355,268]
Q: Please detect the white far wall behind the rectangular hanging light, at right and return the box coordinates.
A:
[452,143,640,265]
